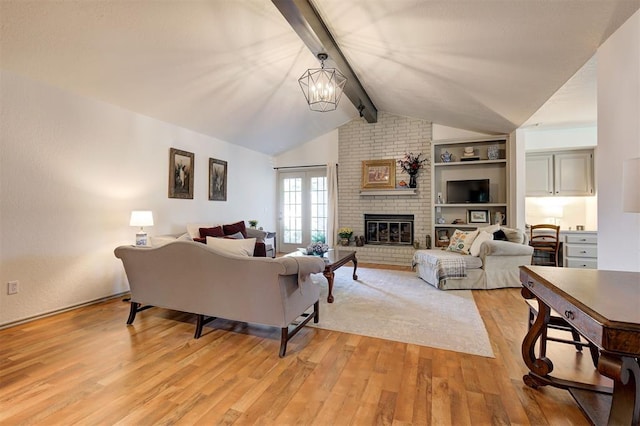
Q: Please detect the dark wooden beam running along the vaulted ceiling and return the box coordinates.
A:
[271,0,378,123]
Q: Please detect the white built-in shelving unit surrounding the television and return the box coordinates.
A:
[431,135,509,246]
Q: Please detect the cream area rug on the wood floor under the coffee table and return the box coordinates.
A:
[309,265,494,358]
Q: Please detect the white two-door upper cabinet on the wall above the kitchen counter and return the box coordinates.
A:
[526,150,595,197]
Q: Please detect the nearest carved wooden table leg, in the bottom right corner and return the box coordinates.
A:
[598,352,640,425]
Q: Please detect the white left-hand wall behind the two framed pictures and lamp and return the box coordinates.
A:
[0,72,275,325]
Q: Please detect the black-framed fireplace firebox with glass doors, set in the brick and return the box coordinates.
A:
[364,214,414,246]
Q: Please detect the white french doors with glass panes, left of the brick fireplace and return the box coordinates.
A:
[277,167,328,253]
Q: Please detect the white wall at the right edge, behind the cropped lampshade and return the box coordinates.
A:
[596,11,640,271]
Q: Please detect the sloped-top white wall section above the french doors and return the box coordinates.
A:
[275,129,338,167]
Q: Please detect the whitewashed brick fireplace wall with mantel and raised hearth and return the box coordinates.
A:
[338,112,431,266]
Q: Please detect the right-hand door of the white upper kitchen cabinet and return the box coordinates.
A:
[556,152,593,197]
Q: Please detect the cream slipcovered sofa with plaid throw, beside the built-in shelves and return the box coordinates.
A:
[413,227,533,290]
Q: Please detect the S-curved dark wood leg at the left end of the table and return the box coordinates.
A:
[522,287,553,388]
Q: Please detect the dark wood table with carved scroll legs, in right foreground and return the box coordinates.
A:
[520,266,640,426]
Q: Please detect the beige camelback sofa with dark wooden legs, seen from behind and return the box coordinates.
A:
[115,240,325,357]
